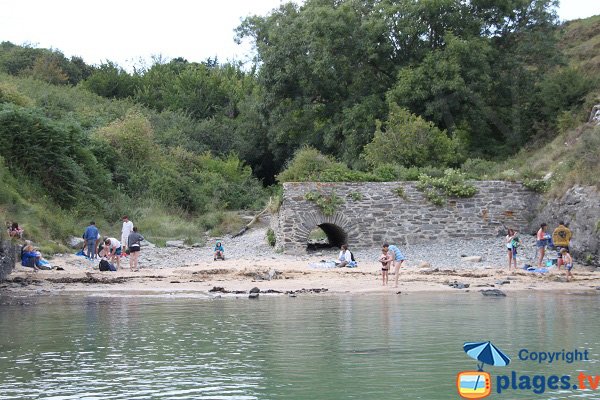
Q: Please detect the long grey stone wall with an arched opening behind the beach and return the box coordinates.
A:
[271,181,540,254]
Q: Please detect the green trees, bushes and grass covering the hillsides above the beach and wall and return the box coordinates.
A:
[0,0,600,248]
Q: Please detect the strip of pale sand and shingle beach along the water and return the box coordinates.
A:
[0,228,600,296]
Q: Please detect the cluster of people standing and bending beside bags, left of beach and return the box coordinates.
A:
[83,215,144,272]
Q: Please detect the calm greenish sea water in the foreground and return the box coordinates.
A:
[0,292,600,400]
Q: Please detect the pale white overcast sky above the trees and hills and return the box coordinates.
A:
[0,0,600,69]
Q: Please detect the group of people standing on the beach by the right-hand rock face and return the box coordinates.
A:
[505,221,573,282]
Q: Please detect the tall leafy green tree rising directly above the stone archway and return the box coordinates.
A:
[238,0,395,170]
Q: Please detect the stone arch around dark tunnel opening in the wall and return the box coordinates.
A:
[297,212,354,247]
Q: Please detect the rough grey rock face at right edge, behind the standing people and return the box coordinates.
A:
[534,186,600,266]
